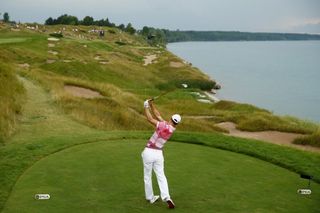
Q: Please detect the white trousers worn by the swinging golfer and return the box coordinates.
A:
[141,148,170,201]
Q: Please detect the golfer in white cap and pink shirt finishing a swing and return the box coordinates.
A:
[141,100,181,209]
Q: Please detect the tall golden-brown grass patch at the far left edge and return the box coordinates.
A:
[0,62,25,142]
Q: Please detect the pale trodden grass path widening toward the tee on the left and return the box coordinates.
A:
[10,77,91,143]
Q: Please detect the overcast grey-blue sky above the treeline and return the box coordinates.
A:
[0,0,320,33]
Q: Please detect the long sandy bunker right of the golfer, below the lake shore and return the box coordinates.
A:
[216,122,320,152]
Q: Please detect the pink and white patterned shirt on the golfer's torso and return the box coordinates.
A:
[147,121,176,149]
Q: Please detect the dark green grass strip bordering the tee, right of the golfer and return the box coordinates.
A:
[172,133,320,183]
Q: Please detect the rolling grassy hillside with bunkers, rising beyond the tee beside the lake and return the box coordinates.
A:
[0,22,317,136]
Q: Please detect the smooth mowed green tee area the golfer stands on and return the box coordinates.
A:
[3,140,320,213]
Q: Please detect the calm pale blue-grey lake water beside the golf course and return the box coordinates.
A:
[167,41,320,123]
